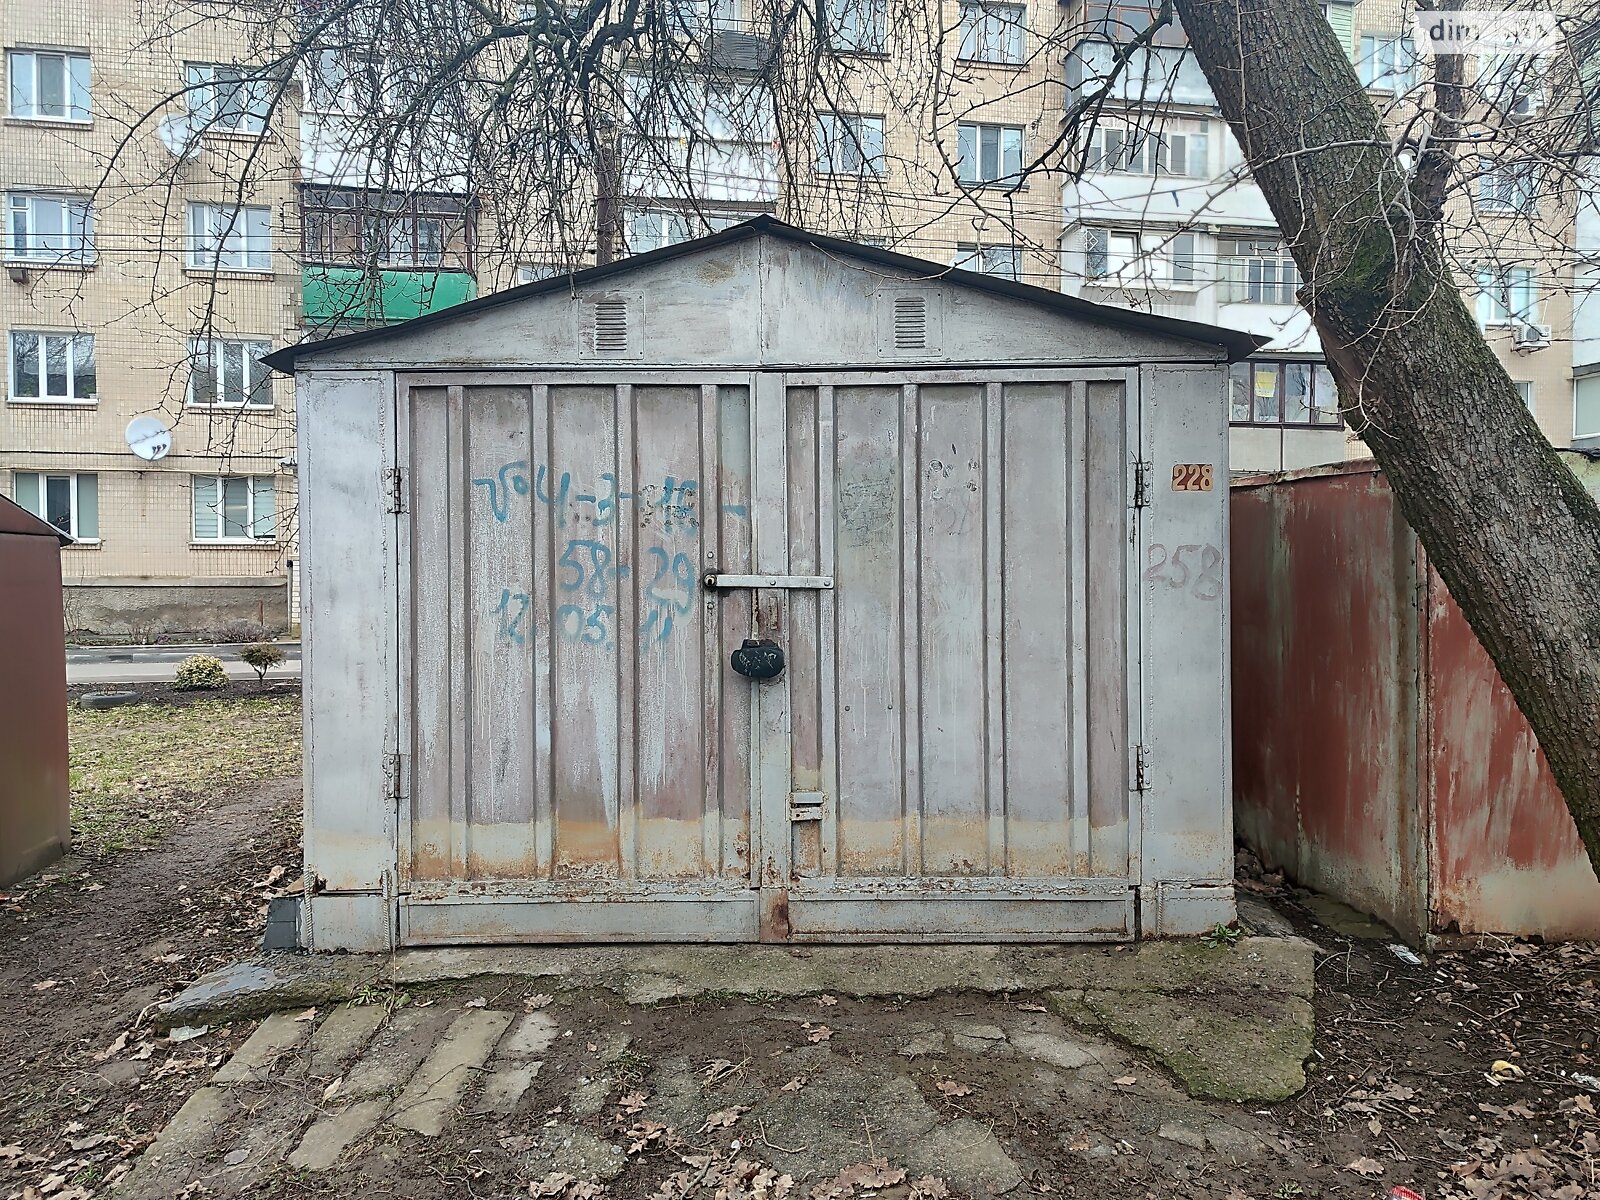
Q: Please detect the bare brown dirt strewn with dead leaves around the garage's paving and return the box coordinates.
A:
[0,701,1600,1200]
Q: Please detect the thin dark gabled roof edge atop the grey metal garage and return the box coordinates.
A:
[262,216,1270,374]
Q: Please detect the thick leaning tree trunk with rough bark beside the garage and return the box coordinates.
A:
[1176,0,1600,870]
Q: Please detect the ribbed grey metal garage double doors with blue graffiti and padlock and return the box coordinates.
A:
[395,371,1139,944]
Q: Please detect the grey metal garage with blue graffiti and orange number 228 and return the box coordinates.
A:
[269,218,1256,950]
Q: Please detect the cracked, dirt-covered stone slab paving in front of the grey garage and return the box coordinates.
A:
[115,942,1310,1200]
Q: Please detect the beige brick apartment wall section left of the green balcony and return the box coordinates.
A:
[0,0,298,634]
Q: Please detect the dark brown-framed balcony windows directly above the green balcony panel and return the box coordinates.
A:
[301,187,475,270]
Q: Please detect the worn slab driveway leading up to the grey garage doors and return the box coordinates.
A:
[117,939,1309,1200]
